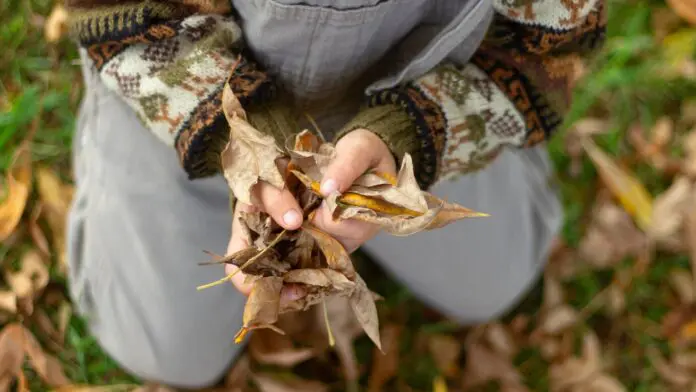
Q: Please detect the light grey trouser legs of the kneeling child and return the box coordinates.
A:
[68,68,562,387]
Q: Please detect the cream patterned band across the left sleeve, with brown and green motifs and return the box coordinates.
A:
[100,15,241,146]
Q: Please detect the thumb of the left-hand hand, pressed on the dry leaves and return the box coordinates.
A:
[252,182,302,230]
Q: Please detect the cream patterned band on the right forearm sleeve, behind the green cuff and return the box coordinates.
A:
[413,64,526,181]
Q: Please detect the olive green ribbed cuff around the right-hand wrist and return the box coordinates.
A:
[334,105,420,167]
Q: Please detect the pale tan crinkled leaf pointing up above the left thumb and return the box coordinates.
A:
[221,112,285,205]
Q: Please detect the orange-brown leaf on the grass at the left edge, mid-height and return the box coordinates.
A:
[0,142,31,241]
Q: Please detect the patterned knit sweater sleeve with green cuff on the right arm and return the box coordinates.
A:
[341,0,606,188]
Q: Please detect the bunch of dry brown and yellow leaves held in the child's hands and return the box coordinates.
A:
[199,82,486,347]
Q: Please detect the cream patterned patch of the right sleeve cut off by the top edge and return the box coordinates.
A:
[493,0,598,30]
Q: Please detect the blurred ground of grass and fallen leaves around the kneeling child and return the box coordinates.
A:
[0,0,696,392]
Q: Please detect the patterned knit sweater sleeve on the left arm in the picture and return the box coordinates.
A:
[67,0,275,178]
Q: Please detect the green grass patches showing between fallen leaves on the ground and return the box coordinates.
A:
[0,0,696,391]
